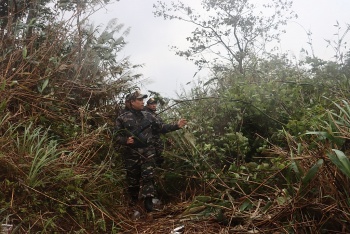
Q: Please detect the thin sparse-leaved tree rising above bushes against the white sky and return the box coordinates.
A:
[154,0,297,74]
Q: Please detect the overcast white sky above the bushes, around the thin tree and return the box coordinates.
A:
[89,0,350,98]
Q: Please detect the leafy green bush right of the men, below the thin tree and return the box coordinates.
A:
[167,51,347,166]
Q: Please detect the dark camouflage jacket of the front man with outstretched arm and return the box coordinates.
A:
[115,110,179,148]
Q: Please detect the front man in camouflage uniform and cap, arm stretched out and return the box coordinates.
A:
[115,91,187,211]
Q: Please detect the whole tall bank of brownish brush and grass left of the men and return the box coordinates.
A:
[0,1,136,233]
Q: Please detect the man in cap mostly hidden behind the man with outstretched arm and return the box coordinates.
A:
[144,98,172,167]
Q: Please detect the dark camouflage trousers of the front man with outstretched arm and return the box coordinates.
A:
[123,147,156,200]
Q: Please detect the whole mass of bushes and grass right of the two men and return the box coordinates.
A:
[155,22,350,232]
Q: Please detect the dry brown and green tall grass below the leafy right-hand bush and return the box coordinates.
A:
[157,100,350,233]
